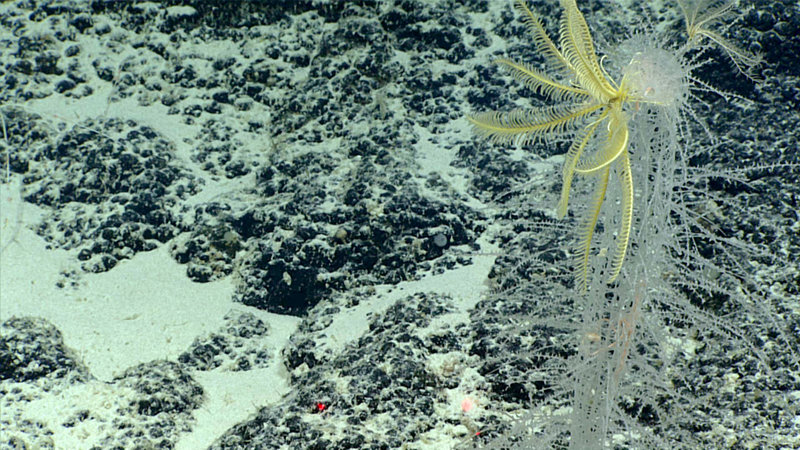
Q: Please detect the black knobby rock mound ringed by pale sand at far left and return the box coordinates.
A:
[4,109,203,272]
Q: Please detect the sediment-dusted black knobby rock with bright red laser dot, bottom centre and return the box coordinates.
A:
[211,294,467,450]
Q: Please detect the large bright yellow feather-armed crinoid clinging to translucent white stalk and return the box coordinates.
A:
[469,0,668,289]
